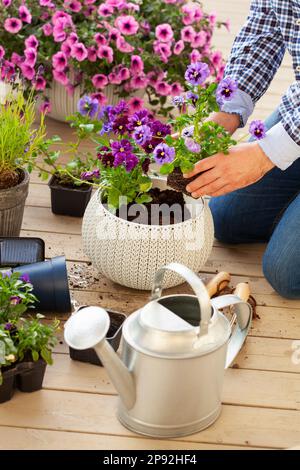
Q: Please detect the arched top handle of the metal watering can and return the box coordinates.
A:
[151,263,212,336]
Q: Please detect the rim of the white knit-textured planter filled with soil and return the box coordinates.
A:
[96,176,205,232]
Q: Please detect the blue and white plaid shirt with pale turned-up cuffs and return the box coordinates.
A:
[222,0,300,170]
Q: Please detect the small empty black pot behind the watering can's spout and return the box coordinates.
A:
[69,307,126,367]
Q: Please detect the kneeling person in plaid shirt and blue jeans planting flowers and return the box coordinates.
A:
[187,0,300,299]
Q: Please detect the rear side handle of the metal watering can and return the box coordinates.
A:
[211,294,252,369]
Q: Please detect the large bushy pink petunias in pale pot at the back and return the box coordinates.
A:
[0,0,228,119]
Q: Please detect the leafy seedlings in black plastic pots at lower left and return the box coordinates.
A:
[0,271,59,402]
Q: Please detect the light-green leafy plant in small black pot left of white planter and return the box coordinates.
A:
[37,115,101,217]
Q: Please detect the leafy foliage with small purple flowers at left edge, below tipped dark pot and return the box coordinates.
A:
[0,272,37,324]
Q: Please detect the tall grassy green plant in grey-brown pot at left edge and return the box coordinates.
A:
[0,88,45,236]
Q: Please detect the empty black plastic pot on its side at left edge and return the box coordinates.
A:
[0,237,45,268]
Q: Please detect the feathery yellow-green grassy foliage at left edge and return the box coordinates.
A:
[0,88,45,175]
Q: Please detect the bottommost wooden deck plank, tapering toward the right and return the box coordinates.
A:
[0,426,255,452]
